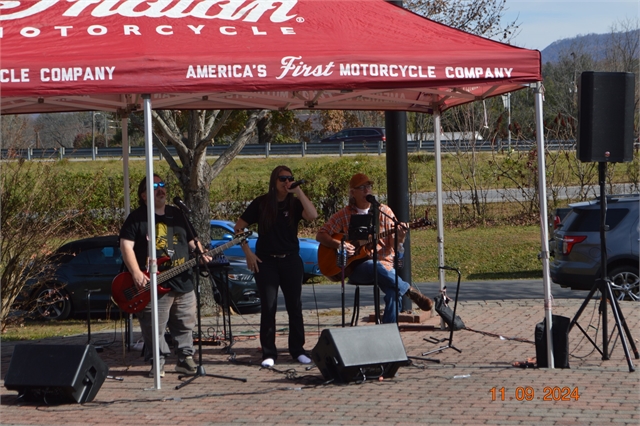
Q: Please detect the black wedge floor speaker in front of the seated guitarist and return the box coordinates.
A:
[311,324,408,383]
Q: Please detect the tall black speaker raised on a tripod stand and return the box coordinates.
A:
[577,71,635,163]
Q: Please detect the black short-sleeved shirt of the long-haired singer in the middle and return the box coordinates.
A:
[240,194,303,257]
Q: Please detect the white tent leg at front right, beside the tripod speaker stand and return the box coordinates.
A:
[535,82,554,368]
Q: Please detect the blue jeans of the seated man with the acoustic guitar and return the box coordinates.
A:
[349,260,410,324]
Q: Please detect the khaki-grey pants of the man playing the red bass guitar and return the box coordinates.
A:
[137,291,196,363]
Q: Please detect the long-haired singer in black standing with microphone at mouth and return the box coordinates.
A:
[235,166,318,368]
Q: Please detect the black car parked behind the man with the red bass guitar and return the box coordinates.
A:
[18,235,260,320]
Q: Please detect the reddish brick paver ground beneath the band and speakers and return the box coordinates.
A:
[0,299,640,426]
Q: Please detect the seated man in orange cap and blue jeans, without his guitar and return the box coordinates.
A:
[316,173,433,323]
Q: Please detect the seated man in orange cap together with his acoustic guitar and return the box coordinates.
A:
[316,173,433,323]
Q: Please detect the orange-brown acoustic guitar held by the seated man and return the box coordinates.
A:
[318,218,431,282]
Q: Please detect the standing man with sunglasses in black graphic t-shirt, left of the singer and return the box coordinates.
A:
[120,174,211,377]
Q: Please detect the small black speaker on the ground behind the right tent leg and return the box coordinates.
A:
[535,315,571,368]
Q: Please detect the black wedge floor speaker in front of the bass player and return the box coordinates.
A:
[4,344,109,404]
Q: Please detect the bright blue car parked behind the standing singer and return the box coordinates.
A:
[210,220,322,282]
